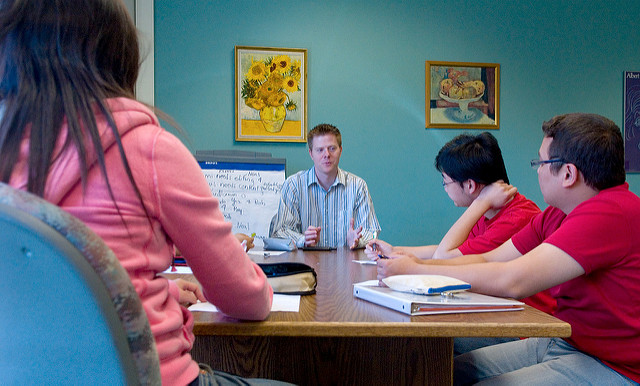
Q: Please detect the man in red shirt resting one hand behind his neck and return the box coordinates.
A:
[365,132,555,320]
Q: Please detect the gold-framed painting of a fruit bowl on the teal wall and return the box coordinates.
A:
[425,61,500,129]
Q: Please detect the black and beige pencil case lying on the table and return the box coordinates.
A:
[258,262,318,295]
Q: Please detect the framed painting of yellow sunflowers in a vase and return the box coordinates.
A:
[235,46,307,142]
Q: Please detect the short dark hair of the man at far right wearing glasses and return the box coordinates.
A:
[542,113,626,190]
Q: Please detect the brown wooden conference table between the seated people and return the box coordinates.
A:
[171,248,571,385]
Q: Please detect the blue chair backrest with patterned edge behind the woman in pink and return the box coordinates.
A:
[0,183,161,385]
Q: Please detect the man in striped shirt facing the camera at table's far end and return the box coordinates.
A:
[271,123,380,249]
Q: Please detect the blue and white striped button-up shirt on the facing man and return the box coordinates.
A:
[271,167,380,247]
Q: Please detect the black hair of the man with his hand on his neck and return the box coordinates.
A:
[435,132,509,185]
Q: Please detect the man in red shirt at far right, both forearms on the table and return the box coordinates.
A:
[378,114,640,385]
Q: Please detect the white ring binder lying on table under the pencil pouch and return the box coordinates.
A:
[353,280,524,315]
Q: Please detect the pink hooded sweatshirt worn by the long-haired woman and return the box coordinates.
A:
[10,98,273,385]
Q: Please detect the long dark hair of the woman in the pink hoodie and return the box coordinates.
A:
[0,0,148,217]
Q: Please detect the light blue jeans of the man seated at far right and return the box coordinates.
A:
[453,338,638,385]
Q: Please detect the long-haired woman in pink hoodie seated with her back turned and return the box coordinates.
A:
[0,0,280,385]
